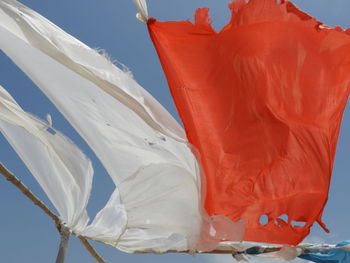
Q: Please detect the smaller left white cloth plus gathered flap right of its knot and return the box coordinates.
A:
[0,86,127,244]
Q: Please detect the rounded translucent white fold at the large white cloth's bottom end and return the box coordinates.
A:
[118,164,201,252]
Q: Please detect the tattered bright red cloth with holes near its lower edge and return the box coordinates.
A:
[148,0,350,245]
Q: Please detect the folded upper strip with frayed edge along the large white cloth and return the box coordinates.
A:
[0,0,182,141]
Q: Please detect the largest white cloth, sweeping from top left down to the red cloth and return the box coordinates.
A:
[0,0,243,252]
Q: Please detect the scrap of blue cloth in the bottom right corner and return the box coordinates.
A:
[299,241,350,263]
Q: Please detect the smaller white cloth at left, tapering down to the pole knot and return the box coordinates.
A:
[0,86,93,231]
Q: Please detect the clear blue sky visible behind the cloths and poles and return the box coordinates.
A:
[0,0,350,263]
